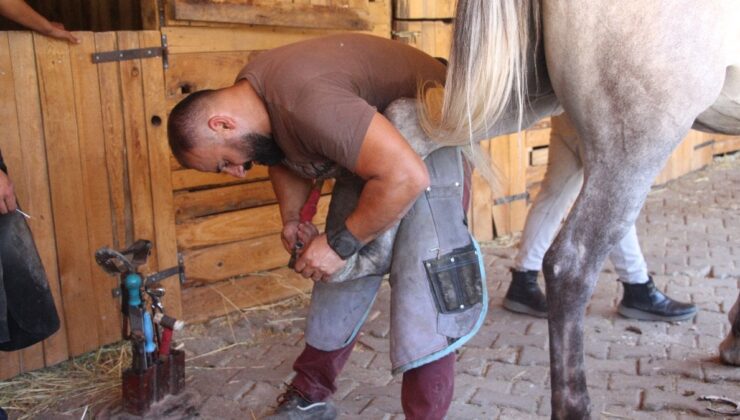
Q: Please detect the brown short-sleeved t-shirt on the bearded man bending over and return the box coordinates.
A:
[237,34,445,178]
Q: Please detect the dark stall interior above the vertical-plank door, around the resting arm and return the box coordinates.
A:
[0,0,142,32]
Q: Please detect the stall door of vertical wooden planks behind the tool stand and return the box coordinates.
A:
[0,31,181,379]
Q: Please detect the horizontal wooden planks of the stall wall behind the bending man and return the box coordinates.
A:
[162,0,390,321]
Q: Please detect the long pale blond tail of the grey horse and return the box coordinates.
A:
[422,0,539,144]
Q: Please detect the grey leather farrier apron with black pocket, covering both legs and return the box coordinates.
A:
[306,147,488,374]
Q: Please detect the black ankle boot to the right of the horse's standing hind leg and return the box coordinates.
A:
[618,277,696,321]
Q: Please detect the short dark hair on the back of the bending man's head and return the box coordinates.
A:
[167,89,216,166]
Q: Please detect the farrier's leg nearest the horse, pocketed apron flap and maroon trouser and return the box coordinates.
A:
[390,148,488,419]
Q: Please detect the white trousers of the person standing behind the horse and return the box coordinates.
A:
[514,114,648,284]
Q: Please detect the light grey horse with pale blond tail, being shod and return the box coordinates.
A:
[426,0,740,419]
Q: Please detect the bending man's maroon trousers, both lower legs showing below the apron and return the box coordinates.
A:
[292,341,455,420]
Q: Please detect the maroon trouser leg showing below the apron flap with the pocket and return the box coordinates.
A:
[401,353,455,420]
